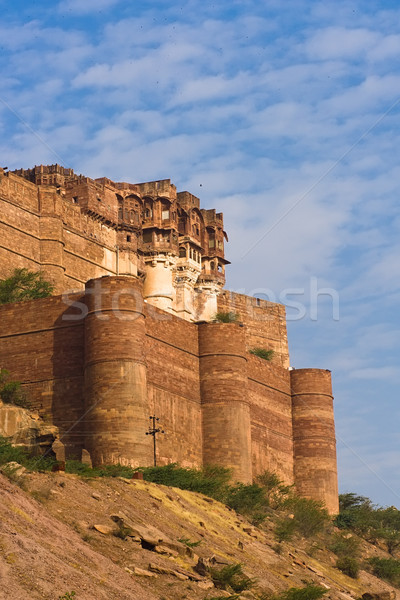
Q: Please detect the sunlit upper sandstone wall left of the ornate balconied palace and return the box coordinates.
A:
[0,173,122,293]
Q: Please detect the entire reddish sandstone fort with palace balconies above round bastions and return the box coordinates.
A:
[0,165,338,513]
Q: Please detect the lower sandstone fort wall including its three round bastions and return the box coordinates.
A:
[0,277,337,512]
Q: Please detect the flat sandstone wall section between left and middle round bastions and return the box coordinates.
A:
[145,304,203,467]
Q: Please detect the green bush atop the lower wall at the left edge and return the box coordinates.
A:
[0,269,54,304]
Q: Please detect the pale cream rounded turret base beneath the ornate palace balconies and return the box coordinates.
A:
[143,254,176,312]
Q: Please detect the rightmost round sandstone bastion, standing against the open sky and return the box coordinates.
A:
[290,369,339,514]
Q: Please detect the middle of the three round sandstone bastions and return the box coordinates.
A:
[199,323,252,483]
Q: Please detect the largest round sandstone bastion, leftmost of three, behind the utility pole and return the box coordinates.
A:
[85,277,151,467]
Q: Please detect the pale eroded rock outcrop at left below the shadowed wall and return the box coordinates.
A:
[0,400,58,455]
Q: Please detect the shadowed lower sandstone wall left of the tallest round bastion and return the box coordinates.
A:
[0,295,84,456]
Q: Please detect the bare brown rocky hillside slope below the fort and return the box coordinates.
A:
[0,473,400,600]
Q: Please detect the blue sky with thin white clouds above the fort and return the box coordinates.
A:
[0,0,400,507]
